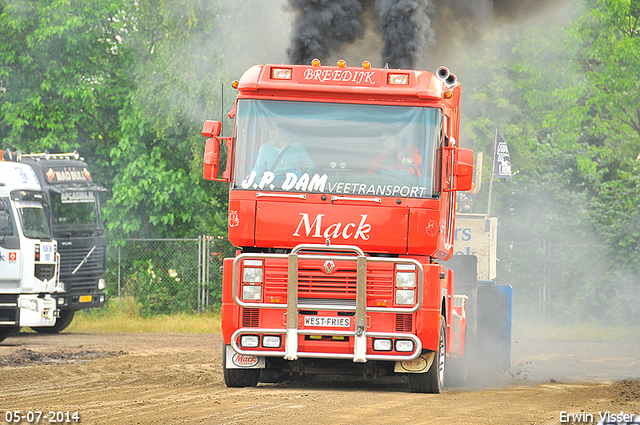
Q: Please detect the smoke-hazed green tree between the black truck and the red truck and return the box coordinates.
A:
[105,0,232,237]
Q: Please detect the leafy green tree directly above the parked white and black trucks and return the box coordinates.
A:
[0,0,132,181]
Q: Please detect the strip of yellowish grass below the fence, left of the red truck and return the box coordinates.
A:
[64,298,220,333]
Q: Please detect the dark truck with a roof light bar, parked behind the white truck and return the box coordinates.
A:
[21,151,107,333]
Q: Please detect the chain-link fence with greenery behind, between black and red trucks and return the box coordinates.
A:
[107,236,233,315]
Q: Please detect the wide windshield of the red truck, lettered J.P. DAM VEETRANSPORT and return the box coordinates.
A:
[232,99,442,198]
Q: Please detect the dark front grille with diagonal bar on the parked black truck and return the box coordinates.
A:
[59,242,105,292]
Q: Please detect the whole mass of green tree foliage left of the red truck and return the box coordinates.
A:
[0,0,226,237]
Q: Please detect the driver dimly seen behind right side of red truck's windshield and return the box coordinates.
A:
[368,132,422,177]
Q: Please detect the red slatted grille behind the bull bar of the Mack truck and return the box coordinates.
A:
[264,259,393,306]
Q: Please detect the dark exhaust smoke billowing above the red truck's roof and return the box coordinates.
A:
[287,0,560,69]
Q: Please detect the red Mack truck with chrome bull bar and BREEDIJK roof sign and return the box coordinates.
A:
[202,60,473,393]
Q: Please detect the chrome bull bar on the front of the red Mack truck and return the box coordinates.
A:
[231,244,424,363]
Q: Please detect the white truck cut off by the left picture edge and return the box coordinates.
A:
[0,156,60,341]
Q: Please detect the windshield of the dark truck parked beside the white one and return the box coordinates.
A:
[51,191,102,234]
